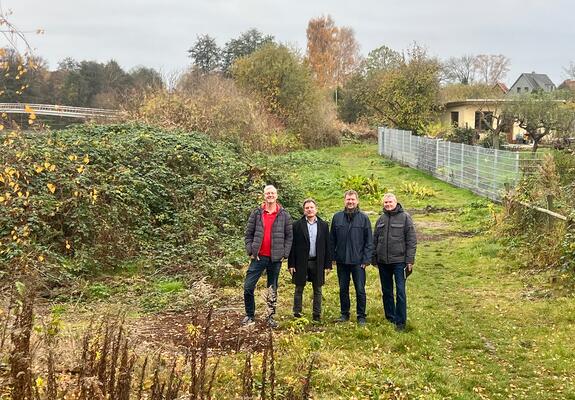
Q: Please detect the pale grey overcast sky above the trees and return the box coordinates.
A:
[4,0,575,85]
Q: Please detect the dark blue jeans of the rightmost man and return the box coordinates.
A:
[378,263,407,326]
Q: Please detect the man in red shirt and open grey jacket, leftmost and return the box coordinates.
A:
[242,185,293,328]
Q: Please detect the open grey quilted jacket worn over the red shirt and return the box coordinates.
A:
[244,204,293,261]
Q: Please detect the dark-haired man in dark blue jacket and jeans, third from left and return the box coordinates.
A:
[331,190,373,326]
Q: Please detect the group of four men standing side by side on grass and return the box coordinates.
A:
[242,185,417,330]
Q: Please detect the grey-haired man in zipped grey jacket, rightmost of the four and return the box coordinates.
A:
[372,193,417,331]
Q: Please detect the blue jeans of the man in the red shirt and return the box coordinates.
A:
[244,256,282,318]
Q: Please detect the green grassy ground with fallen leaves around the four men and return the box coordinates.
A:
[23,144,575,399]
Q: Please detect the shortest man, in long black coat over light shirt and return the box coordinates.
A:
[288,199,331,322]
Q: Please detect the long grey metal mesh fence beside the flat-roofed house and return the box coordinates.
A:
[378,128,540,201]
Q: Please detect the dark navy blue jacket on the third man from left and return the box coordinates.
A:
[330,211,373,265]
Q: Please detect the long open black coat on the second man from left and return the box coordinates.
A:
[288,216,332,286]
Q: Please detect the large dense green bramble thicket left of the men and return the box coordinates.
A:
[0,125,302,283]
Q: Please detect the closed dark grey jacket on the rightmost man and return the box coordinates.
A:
[372,203,417,265]
